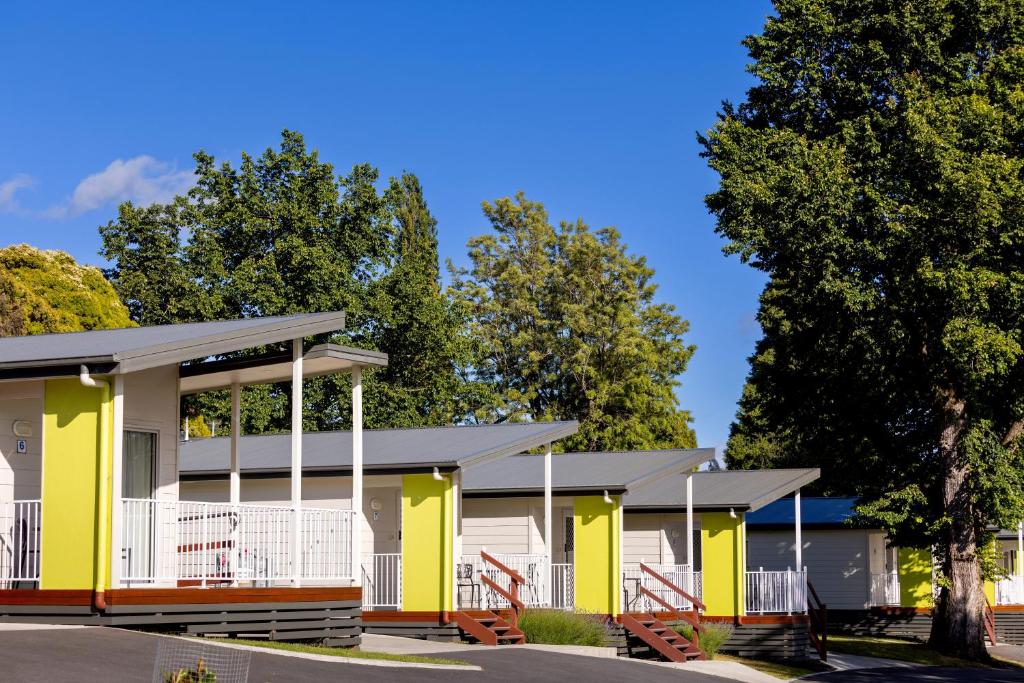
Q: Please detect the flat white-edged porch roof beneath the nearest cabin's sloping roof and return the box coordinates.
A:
[179,344,388,395]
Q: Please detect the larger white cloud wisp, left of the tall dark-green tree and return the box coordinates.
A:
[44,155,194,218]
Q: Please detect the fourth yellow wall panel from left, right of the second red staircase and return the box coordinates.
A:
[700,512,746,616]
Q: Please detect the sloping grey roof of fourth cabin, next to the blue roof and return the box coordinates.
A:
[625,468,821,512]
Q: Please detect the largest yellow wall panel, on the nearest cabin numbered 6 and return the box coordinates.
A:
[40,378,113,590]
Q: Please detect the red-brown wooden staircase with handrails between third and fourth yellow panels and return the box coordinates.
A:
[618,562,705,661]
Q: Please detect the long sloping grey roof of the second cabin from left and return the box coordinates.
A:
[179,422,580,479]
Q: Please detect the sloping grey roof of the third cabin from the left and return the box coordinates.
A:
[462,449,715,496]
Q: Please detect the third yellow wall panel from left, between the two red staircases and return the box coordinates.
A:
[572,496,623,616]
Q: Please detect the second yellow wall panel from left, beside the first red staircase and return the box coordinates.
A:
[401,474,455,611]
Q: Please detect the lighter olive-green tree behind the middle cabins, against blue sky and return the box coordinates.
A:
[452,194,696,450]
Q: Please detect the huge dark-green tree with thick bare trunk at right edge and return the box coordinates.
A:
[702,0,1024,658]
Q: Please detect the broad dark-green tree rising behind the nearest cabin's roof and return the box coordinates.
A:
[100,130,463,432]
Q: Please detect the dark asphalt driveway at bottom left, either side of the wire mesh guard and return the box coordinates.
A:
[0,628,729,683]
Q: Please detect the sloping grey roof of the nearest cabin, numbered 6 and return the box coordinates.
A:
[0,311,345,373]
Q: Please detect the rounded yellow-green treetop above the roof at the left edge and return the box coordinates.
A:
[0,245,133,336]
